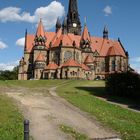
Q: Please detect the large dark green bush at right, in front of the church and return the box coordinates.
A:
[106,72,140,98]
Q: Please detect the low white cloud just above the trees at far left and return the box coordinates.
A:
[0,60,19,71]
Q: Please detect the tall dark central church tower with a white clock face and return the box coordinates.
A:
[67,0,81,35]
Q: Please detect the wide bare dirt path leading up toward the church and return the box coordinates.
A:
[6,87,117,140]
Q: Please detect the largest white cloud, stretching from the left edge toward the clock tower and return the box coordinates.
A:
[0,1,65,29]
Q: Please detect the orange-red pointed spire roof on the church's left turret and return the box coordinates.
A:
[36,19,45,37]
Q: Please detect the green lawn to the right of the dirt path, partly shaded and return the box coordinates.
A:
[57,81,140,140]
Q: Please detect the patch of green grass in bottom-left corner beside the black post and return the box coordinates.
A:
[0,94,23,140]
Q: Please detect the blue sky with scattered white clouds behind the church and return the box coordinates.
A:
[0,0,140,72]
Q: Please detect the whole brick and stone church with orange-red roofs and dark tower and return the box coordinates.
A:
[18,0,128,80]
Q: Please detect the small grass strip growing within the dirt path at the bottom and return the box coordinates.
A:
[59,124,89,140]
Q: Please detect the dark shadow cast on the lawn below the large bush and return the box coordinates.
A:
[76,87,140,111]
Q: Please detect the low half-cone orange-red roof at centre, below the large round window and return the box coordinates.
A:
[62,59,81,67]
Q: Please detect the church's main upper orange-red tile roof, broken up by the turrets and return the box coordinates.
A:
[26,27,126,57]
